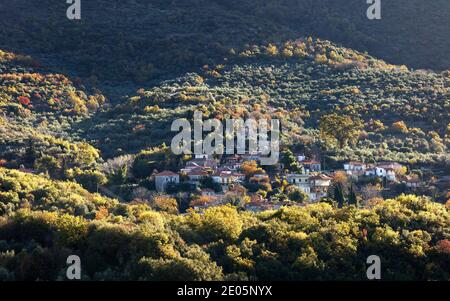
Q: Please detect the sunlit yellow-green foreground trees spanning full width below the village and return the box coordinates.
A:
[0,170,450,280]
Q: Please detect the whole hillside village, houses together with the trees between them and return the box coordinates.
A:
[153,153,448,211]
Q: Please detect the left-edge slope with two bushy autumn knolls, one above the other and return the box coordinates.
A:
[0,50,105,176]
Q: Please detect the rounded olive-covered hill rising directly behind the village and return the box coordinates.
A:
[79,39,450,164]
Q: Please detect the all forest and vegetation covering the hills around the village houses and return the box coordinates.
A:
[0,0,450,280]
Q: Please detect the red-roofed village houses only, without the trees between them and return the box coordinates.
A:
[155,154,432,211]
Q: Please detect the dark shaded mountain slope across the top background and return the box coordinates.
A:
[0,0,450,86]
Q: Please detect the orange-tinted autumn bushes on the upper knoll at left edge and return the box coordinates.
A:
[0,50,105,118]
